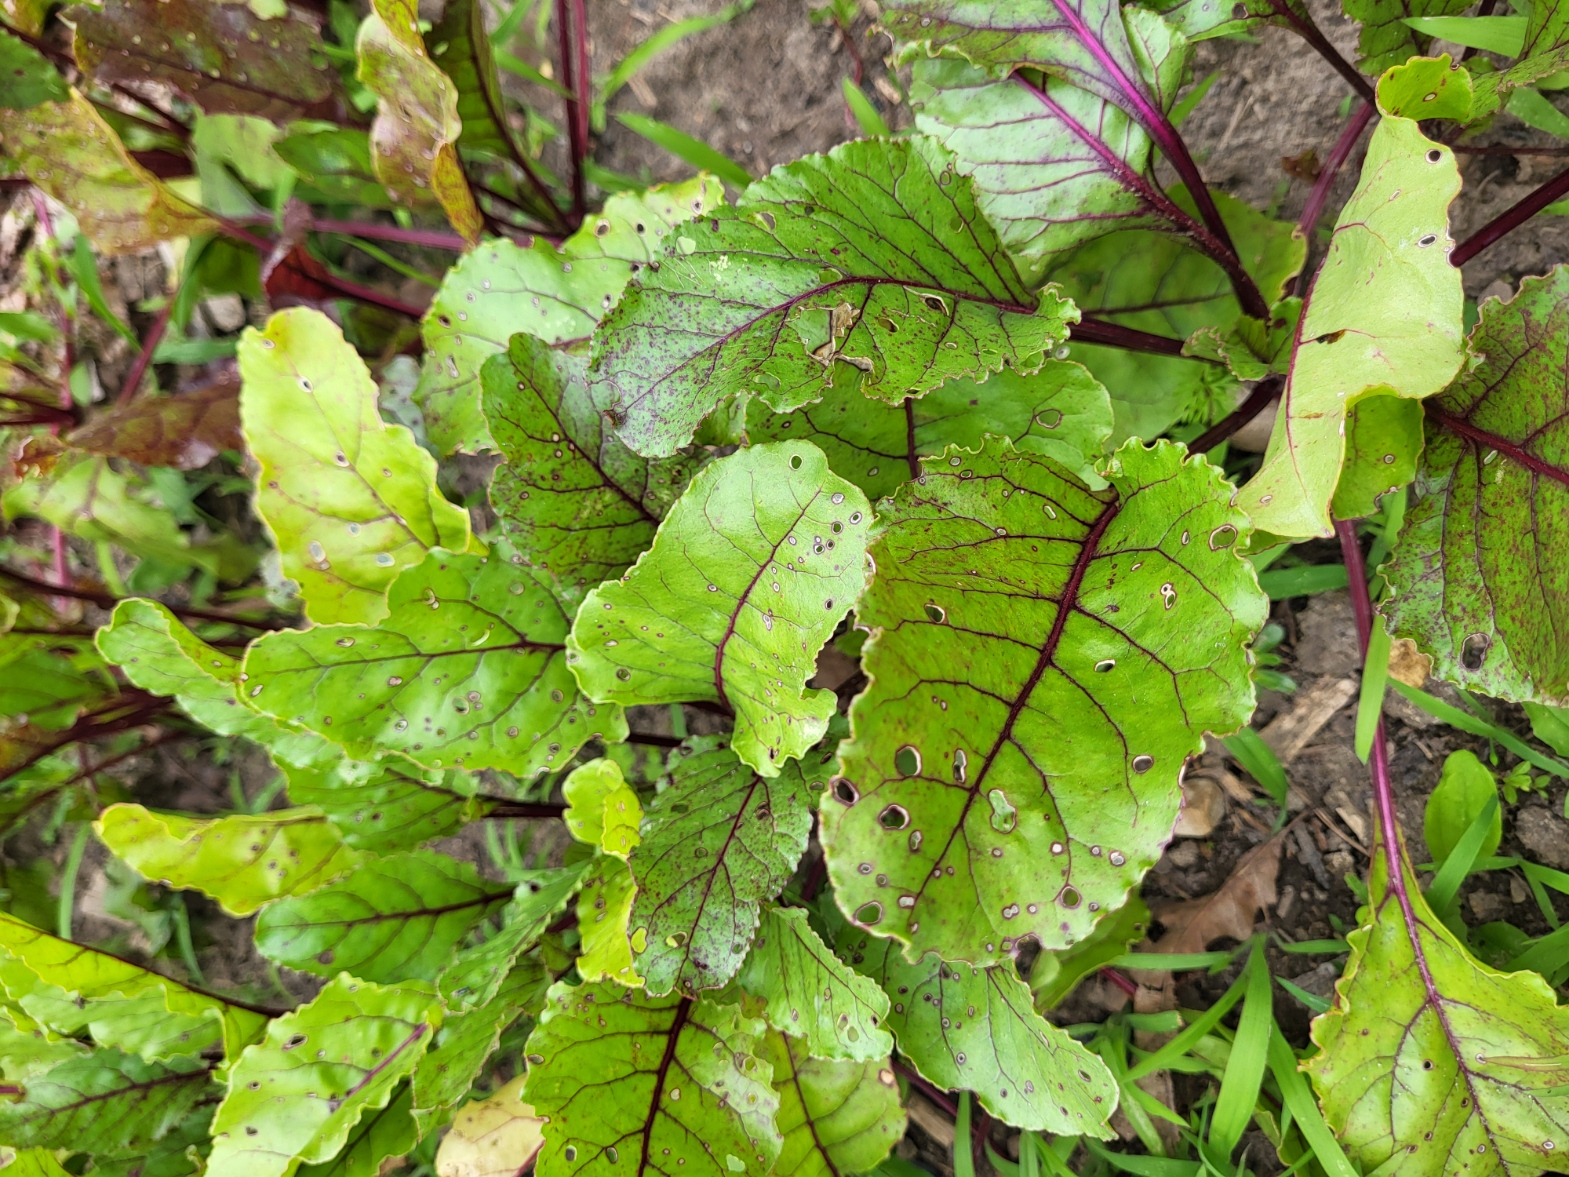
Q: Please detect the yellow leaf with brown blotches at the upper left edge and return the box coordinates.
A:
[5,89,217,254]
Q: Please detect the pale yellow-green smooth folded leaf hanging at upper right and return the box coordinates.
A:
[1238,118,1464,537]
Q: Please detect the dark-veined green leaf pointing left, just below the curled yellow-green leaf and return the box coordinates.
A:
[247,851,513,982]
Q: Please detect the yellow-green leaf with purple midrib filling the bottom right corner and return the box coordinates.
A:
[1307,847,1569,1177]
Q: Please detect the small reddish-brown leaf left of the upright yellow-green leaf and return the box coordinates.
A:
[66,379,245,469]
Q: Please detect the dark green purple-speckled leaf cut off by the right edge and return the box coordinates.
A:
[1384,265,1569,706]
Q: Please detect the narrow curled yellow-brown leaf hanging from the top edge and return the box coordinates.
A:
[355,0,485,243]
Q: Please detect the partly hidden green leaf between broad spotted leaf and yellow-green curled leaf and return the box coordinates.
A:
[289,756,493,851]
